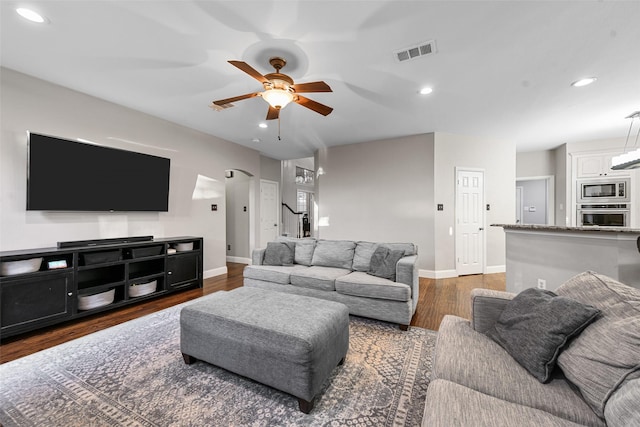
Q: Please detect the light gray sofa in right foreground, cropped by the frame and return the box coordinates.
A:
[422,272,640,427]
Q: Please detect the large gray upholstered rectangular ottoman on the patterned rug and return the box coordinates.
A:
[180,287,349,413]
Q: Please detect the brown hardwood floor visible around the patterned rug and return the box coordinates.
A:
[0,263,505,363]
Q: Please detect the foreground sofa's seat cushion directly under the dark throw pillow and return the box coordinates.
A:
[432,315,605,426]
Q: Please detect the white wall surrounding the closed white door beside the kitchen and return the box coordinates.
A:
[433,133,516,273]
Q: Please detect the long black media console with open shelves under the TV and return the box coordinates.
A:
[0,237,203,338]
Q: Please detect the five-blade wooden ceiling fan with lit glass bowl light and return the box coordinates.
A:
[211,57,333,120]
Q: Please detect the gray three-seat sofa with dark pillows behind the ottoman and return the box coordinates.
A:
[244,237,419,329]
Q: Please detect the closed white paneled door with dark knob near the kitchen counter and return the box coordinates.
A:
[456,169,485,275]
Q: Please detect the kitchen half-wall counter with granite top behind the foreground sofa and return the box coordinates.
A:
[492,224,640,293]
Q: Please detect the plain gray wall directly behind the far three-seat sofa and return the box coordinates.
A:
[315,134,435,269]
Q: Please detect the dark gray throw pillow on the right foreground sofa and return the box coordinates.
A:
[487,288,600,383]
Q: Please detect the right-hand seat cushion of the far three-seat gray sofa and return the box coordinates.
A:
[336,271,411,301]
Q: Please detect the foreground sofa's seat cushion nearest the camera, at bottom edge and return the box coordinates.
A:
[422,380,580,427]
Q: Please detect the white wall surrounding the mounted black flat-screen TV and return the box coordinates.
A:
[0,68,268,276]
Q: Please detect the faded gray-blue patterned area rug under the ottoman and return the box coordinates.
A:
[0,297,436,427]
